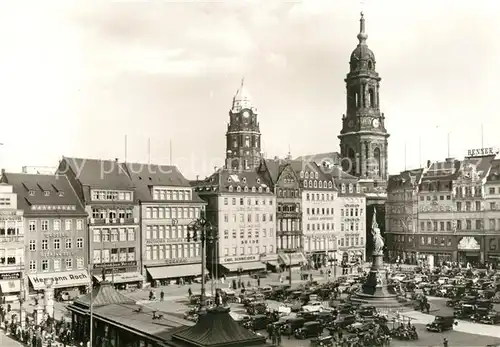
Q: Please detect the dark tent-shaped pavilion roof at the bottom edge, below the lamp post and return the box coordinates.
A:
[172,307,266,347]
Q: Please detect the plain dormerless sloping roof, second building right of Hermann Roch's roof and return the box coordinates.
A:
[58,157,134,190]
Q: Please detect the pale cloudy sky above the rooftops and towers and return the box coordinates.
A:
[0,0,500,178]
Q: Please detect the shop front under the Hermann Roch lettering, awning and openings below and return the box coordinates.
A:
[28,270,90,297]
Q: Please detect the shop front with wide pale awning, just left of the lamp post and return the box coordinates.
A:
[146,258,204,287]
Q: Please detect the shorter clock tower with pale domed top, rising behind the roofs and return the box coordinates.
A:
[226,80,261,170]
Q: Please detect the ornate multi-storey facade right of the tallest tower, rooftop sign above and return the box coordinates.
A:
[387,155,500,266]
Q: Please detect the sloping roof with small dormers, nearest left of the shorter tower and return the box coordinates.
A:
[125,163,203,202]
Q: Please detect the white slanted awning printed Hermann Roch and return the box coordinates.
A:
[28,270,90,290]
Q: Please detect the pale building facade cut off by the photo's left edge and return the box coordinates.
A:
[0,183,24,302]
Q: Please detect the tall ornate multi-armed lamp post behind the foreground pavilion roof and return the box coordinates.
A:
[187,216,219,309]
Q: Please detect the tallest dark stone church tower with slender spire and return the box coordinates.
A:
[338,13,389,187]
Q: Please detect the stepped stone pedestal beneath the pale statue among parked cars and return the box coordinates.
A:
[351,253,407,309]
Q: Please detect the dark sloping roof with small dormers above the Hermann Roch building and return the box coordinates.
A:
[2,173,86,216]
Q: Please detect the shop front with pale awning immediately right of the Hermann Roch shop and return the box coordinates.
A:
[92,260,144,289]
